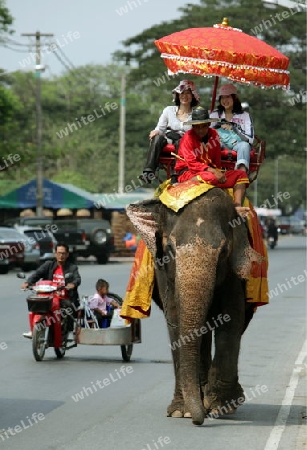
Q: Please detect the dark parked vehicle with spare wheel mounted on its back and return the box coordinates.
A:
[4,217,115,264]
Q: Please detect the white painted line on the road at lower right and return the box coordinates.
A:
[264,340,307,450]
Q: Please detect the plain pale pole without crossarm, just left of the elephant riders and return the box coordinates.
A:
[118,73,126,194]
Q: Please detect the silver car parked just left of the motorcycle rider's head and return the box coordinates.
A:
[15,225,57,264]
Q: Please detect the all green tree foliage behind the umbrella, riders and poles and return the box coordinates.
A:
[0,0,306,212]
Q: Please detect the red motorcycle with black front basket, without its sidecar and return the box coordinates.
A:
[19,277,77,361]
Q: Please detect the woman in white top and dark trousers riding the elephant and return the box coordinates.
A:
[139,80,199,183]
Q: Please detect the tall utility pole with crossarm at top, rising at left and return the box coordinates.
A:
[21,31,54,216]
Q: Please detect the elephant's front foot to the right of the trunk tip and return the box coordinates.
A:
[203,383,245,418]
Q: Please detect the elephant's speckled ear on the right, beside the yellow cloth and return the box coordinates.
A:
[230,221,263,279]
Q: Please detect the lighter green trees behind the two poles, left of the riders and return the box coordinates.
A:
[0,65,156,192]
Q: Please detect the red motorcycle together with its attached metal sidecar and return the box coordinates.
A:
[17,273,142,361]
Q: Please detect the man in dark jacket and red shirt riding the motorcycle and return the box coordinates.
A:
[21,242,81,340]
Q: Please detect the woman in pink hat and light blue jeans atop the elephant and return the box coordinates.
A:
[210,84,254,172]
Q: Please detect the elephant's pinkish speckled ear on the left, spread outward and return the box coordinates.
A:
[126,198,162,256]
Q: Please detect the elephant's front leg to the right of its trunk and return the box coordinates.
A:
[204,277,245,415]
